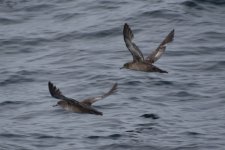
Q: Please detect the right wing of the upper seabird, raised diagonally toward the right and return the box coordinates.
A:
[145,29,174,64]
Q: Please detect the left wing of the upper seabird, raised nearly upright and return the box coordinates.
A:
[123,23,144,62]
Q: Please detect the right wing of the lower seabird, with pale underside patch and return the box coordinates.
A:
[80,83,117,106]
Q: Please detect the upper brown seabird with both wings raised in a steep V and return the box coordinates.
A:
[120,23,174,73]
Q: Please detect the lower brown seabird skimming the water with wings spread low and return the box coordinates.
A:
[48,81,117,115]
